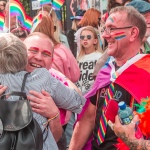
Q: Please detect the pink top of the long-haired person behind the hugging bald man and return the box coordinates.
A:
[52,44,80,82]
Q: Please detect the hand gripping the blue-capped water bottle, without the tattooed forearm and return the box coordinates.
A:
[113,115,139,140]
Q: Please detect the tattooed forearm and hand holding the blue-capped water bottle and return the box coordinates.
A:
[114,116,150,150]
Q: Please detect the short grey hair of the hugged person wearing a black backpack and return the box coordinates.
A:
[0,33,28,74]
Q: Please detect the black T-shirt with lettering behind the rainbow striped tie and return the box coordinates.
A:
[90,84,131,150]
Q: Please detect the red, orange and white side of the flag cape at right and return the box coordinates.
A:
[112,54,150,103]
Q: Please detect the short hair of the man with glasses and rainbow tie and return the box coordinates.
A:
[110,6,147,41]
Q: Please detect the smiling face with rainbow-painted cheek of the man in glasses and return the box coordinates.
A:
[102,12,132,58]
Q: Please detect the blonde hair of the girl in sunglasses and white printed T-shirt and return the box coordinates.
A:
[77,26,103,60]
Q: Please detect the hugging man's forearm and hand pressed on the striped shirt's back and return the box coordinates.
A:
[28,90,62,142]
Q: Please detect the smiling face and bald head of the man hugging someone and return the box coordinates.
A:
[24,35,53,72]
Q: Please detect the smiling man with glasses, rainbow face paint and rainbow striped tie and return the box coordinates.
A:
[70,6,146,150]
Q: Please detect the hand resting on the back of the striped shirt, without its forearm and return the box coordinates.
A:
[27,90,59,118]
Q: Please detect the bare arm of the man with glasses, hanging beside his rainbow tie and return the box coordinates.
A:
[69,103,96,150]
